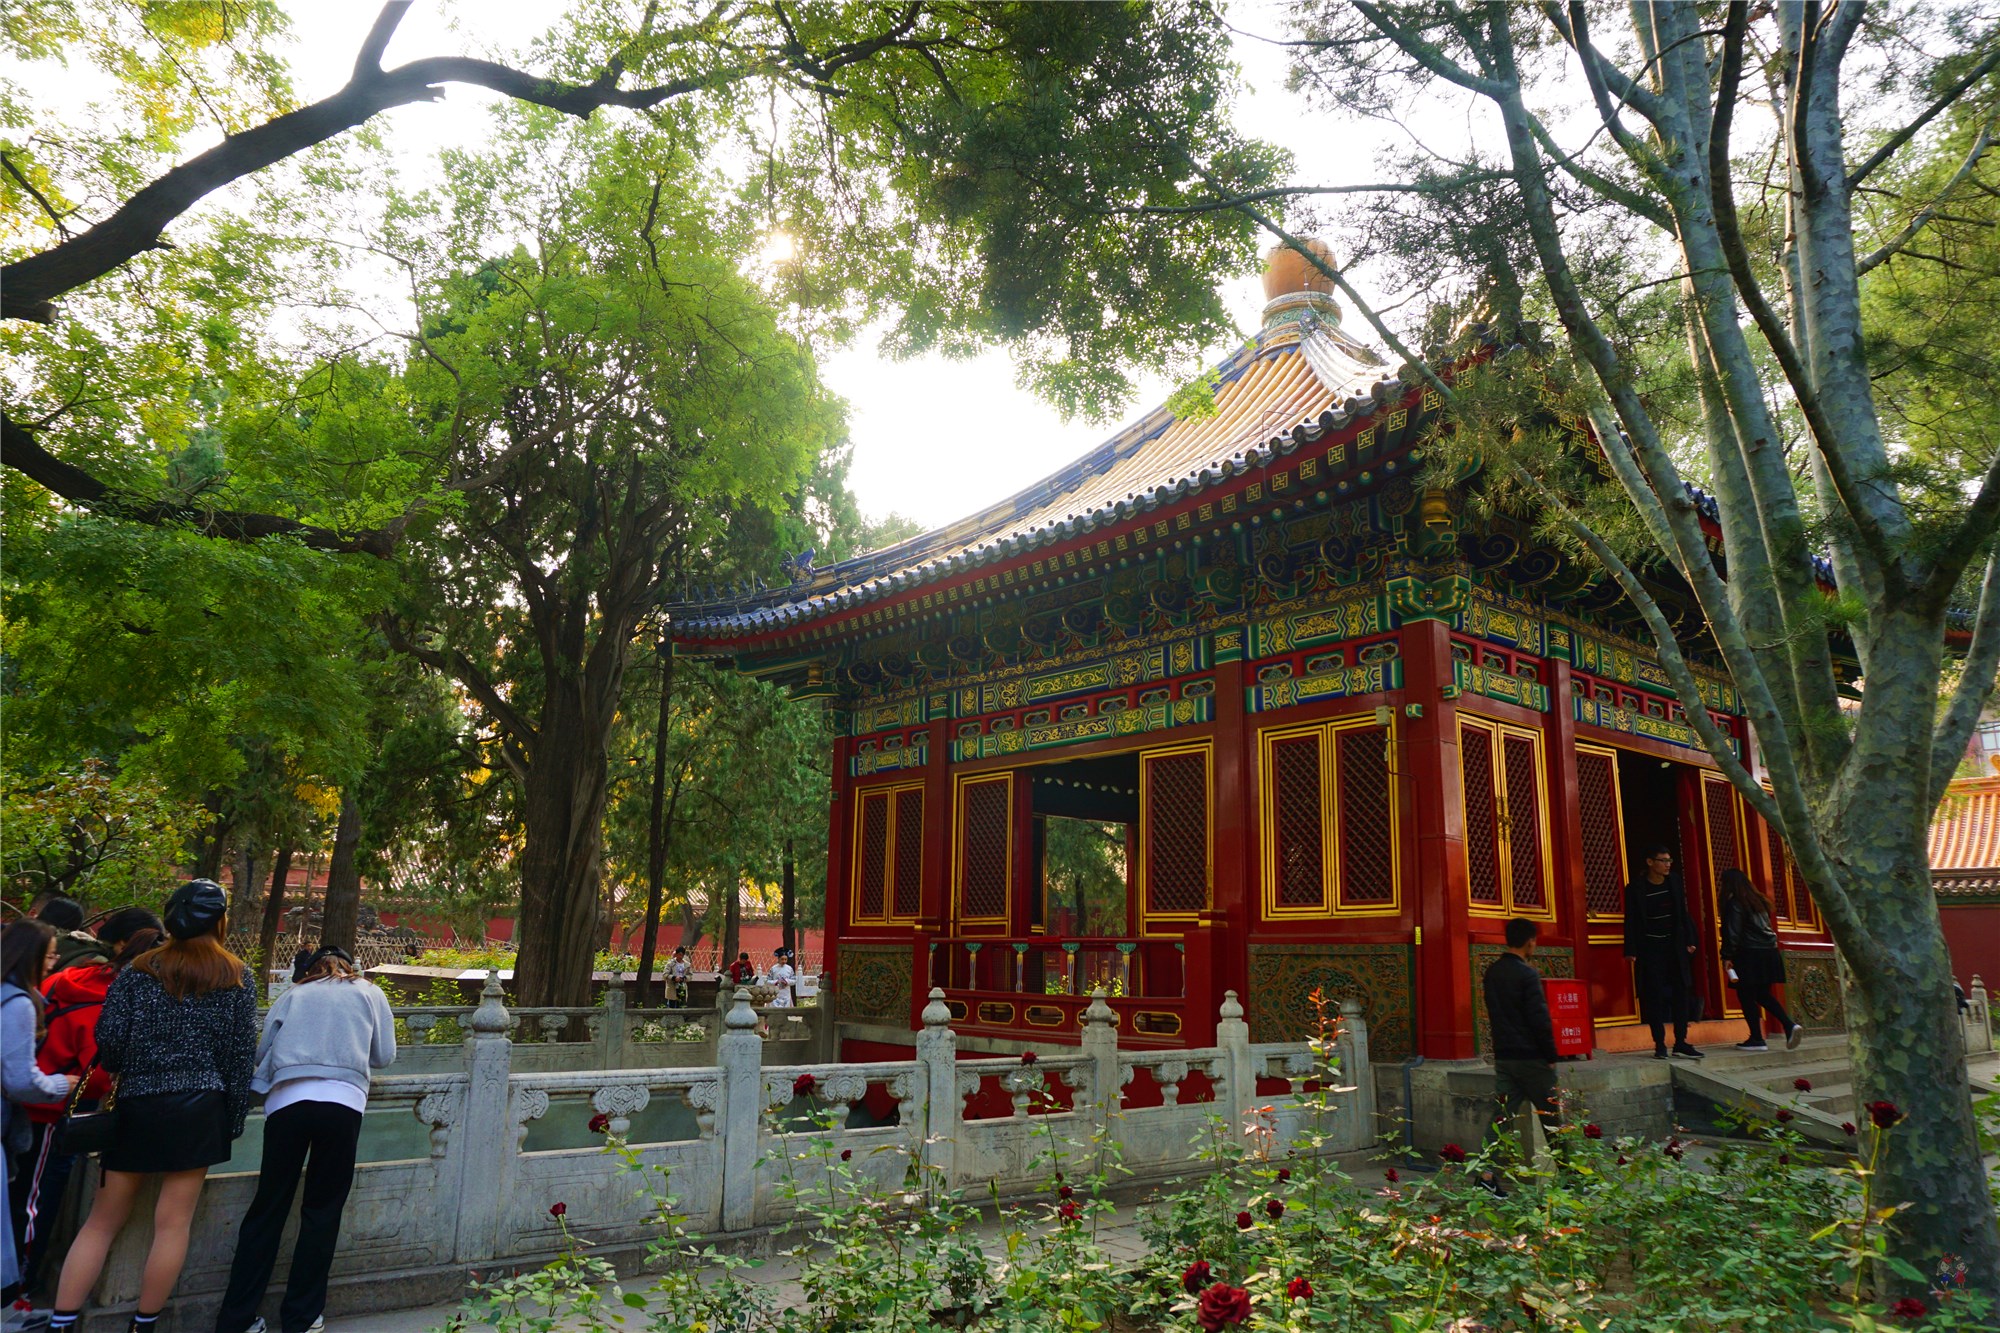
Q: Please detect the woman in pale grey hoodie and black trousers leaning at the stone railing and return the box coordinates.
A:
[216,947,396,1333]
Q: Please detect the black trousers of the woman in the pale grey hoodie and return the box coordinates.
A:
[216,1101,362,1333]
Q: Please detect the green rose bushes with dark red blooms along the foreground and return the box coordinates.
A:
[446,996,1994,1333]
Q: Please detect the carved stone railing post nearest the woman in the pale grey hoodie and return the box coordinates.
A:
[444,971,516,1267]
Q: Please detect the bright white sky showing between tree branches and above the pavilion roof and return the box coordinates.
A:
[191,0,1456,526]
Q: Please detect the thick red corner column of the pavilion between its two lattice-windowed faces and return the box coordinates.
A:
[1400,620,1472,1061]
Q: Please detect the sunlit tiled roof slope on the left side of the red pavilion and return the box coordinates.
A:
[668,310,1406,638]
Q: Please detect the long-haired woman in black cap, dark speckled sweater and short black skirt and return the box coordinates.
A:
[50,879,256,1333]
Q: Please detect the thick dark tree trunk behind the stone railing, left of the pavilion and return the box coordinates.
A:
[514,679,606,1007]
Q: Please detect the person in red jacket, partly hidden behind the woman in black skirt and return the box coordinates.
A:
[16,907,164,1275]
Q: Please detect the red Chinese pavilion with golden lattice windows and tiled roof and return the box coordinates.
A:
[672,241,1840,1059]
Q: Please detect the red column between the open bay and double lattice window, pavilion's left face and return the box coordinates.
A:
[1188,656,1258,1008]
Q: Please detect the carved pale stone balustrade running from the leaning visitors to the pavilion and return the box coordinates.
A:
[74,979,1374,1333]
